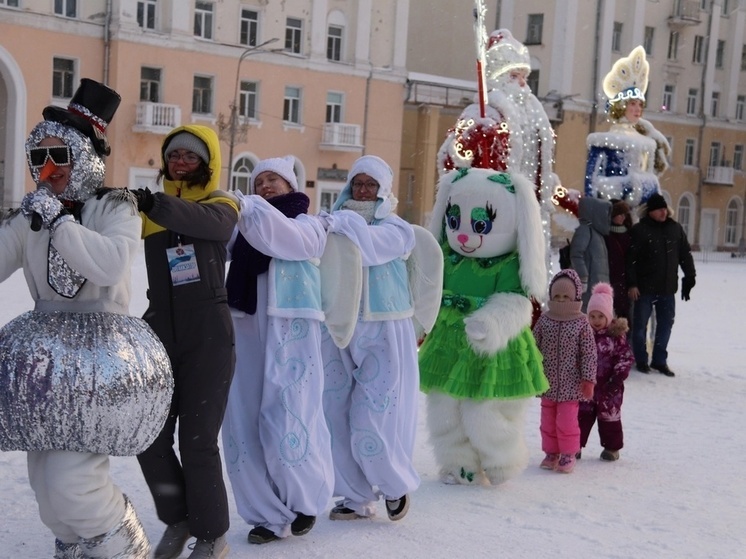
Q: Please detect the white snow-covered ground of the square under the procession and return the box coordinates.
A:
[0,249,746,559]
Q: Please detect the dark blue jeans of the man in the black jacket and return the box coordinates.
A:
[632,295,676,365]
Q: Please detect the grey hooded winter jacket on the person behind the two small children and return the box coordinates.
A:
[570,197,612,310]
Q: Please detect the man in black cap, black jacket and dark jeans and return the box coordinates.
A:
[627,194,696,377]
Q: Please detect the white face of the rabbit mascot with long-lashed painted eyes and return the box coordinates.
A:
[444,173,518,258]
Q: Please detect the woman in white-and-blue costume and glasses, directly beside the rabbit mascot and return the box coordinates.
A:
[322,155,420,520]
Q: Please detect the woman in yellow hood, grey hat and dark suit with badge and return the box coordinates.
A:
[135,125,238,558]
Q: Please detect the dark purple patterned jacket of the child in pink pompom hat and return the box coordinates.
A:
[580,318,635,421]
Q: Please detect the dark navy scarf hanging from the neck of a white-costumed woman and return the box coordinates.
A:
[225,192,311,314]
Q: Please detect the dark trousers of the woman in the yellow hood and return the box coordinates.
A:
[137,303,235,540]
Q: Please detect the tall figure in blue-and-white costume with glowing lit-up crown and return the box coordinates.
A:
[585,46,671,207]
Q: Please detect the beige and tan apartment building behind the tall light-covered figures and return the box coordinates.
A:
[400,0,746,251]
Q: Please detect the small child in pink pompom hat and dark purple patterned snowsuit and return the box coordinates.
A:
[577,283,634,461]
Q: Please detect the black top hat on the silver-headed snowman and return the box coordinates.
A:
[42,78,122,156]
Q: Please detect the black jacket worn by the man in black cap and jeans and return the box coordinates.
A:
[627,212,696,295]
